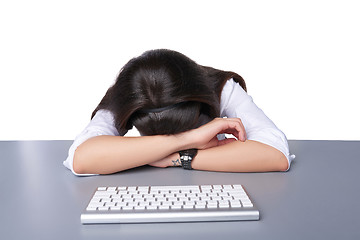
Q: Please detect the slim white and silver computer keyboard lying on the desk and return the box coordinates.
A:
[81,184,259,224]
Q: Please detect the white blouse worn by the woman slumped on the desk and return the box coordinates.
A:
[64,79,295,176]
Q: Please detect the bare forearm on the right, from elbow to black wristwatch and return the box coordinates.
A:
[192,140,288,172]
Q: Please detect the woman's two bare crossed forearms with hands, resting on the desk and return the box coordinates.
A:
[73,118,287,174]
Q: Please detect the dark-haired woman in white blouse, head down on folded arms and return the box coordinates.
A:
[64,49,294,175]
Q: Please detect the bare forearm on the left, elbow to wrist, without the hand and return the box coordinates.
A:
[73,135,187,174]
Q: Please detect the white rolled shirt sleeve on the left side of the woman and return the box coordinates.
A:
[63,109,119,176]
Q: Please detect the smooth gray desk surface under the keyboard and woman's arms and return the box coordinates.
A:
[0,141,360,240]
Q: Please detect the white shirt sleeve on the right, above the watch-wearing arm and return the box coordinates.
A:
[220,79,295,170]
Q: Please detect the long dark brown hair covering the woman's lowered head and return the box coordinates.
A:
[92,49,246,135]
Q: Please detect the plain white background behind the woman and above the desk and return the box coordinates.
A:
[0,0,360,140]
